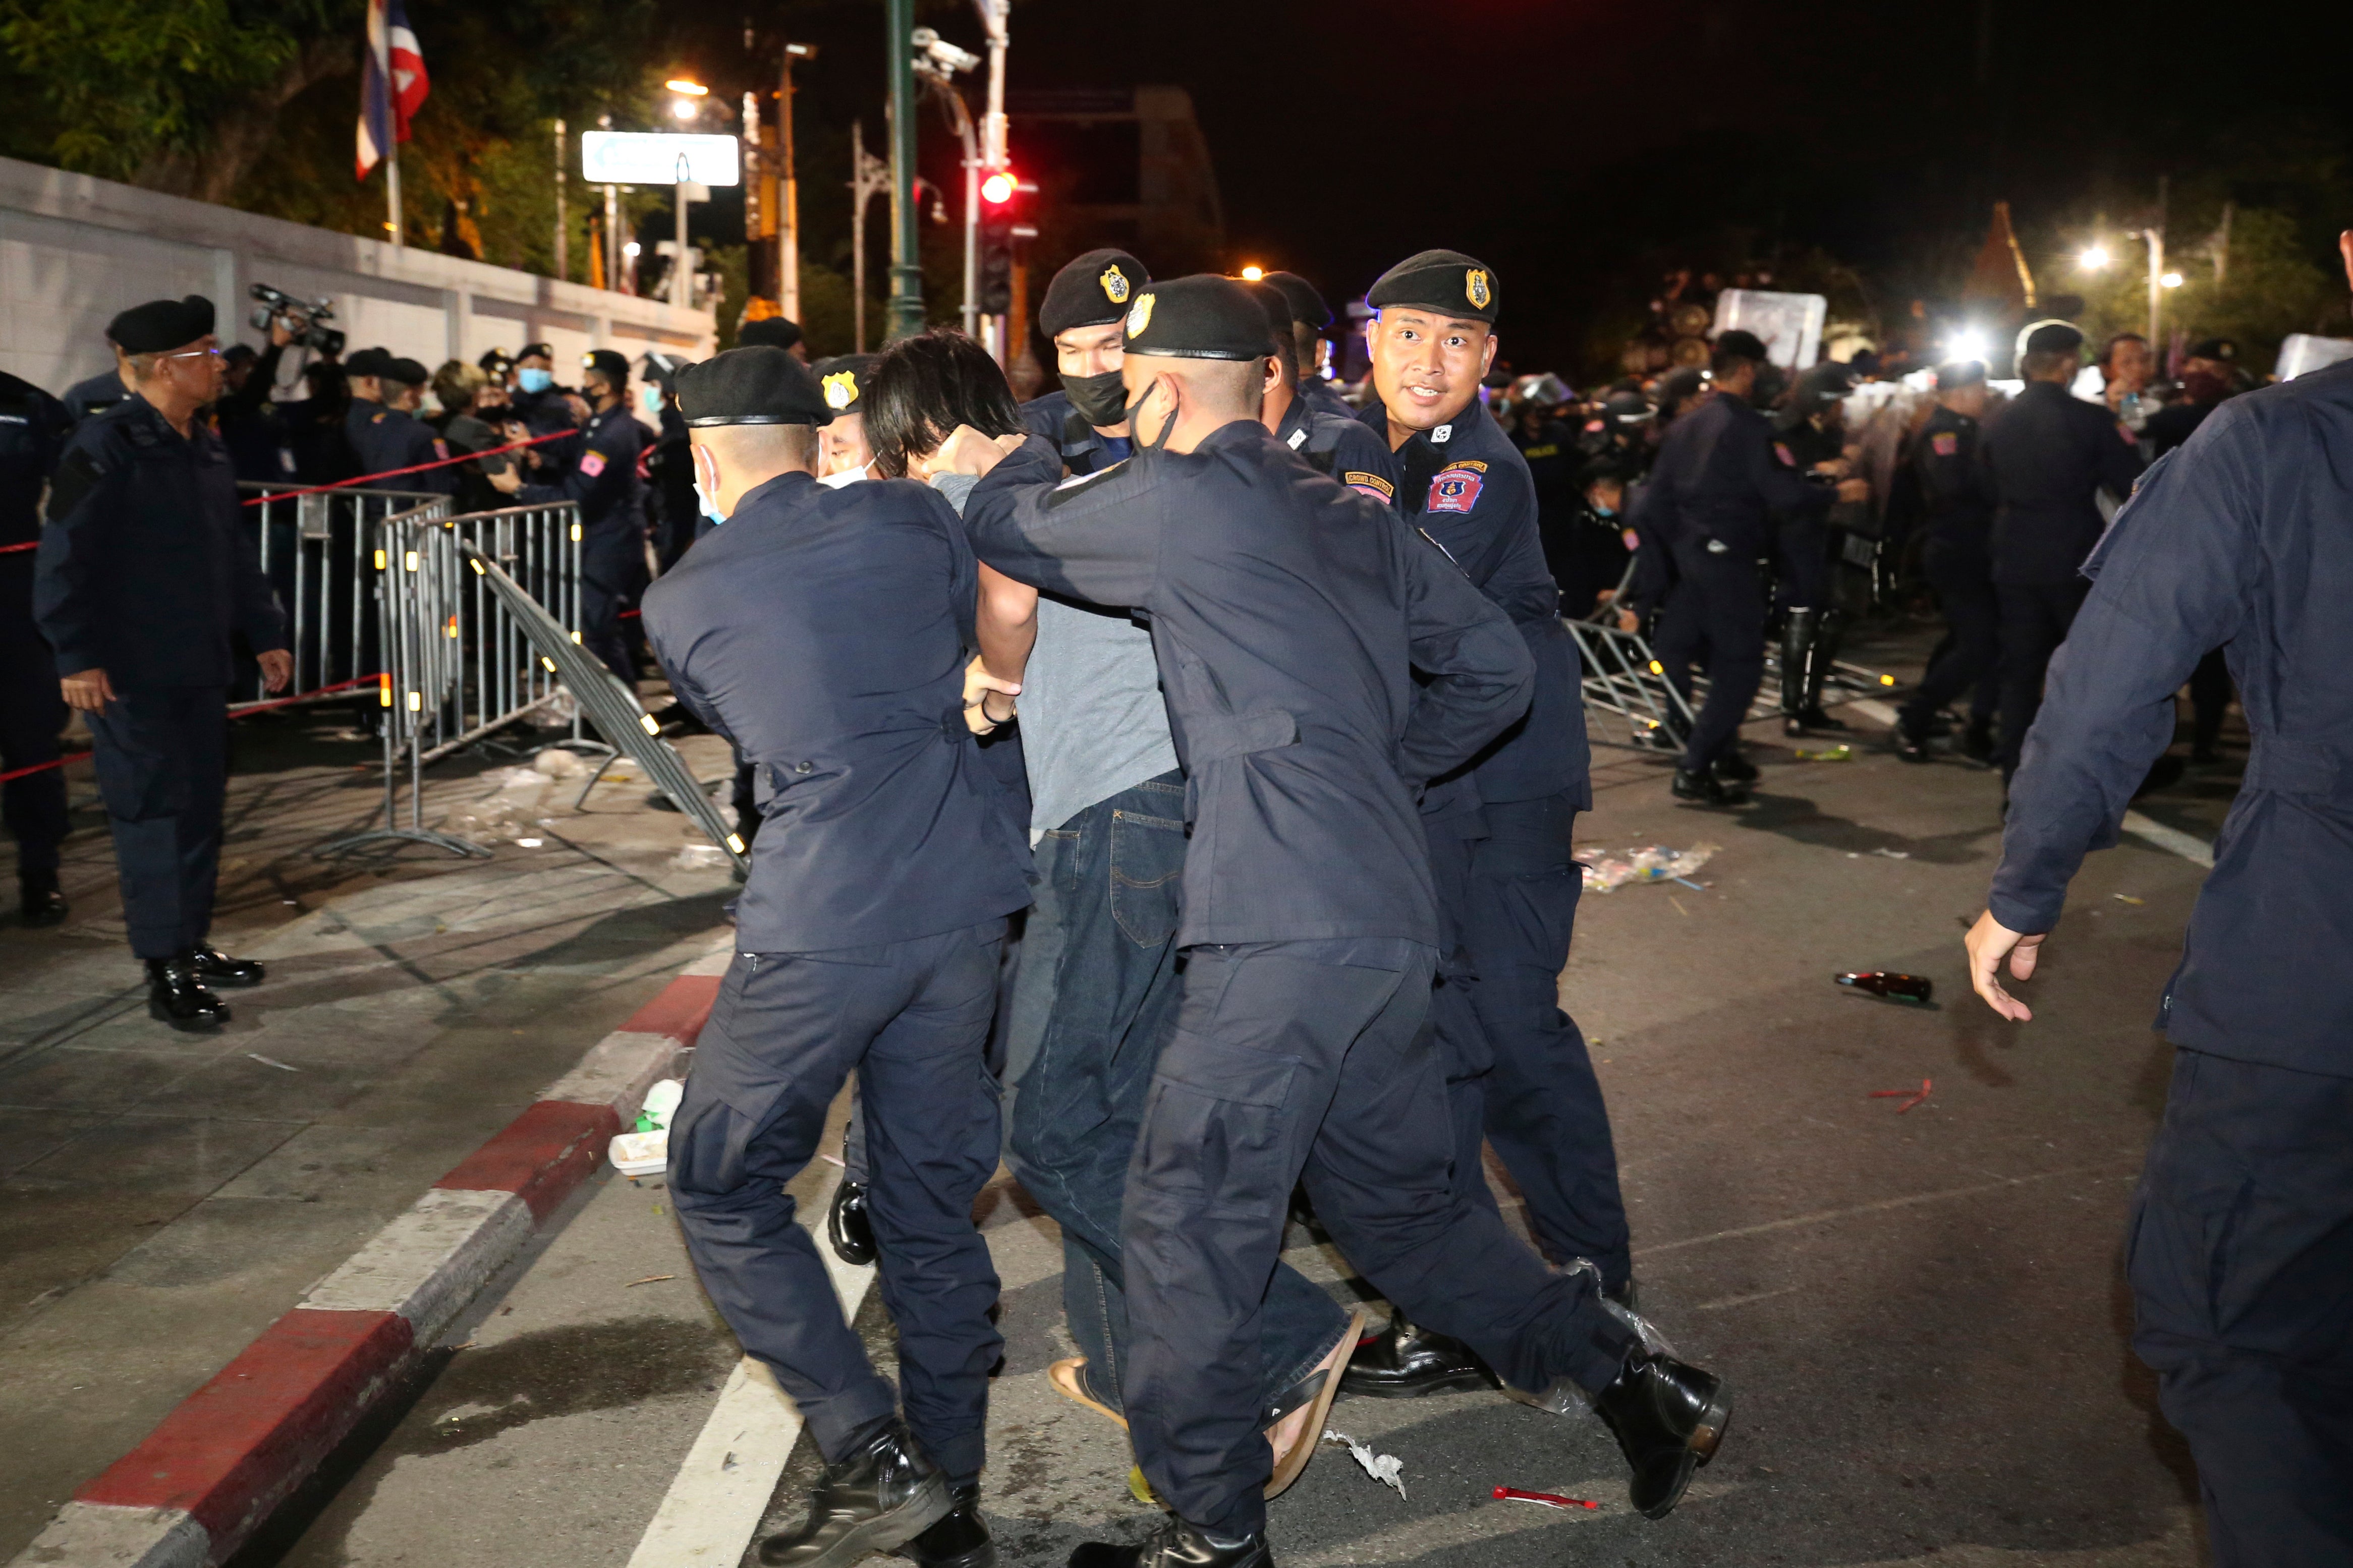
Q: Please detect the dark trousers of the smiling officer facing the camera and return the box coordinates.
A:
[1433,792,1633,1286]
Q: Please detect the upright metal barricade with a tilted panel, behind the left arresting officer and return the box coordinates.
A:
[320,498,588,856]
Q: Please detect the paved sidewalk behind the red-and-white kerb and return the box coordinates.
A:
[0,710,734,1558]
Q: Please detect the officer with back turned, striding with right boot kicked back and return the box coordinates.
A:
[945,268,1729,1568]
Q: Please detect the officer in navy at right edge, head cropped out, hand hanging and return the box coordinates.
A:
[1970,230,2353,1568]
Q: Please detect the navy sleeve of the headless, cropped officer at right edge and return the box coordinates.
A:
[1988,426,2264,931]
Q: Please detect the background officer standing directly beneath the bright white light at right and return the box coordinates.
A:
[1896,360,2002,762]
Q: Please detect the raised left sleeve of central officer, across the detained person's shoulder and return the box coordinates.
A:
[965,435,1167,609]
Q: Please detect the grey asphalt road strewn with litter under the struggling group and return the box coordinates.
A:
[240,630,2235,1568]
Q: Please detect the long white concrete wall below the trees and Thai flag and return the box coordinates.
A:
[0,157,715,392]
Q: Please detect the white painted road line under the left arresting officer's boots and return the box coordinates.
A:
[628,1176,875,1568]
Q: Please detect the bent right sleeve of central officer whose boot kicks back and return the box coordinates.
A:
[1395,522,1537,785]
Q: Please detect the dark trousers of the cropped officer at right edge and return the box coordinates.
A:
[2125,1051,2353,1568]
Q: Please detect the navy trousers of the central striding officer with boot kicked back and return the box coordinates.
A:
[1125,938,1633,1530]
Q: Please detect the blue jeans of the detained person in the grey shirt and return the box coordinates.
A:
[1005,774,1348,1406]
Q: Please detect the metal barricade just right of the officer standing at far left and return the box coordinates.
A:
[231,482,450,712]
